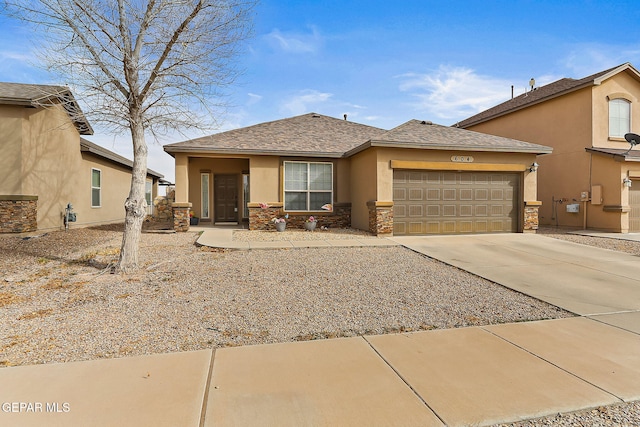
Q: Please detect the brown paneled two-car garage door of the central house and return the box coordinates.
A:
[393,170,520,235]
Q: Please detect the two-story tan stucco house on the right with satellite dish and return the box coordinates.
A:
[458,63,640,233]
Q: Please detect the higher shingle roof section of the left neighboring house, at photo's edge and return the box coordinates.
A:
[0,82,93,135]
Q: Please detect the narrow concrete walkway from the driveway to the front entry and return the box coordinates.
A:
[196,227,400,250]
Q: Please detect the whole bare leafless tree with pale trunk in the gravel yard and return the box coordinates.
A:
[5,0,255,271]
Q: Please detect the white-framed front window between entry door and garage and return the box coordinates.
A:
[284,162,333,211]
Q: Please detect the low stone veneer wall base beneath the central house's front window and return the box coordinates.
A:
[248,202,351,230]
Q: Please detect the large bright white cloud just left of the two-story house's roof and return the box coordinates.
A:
[398,65,517,121]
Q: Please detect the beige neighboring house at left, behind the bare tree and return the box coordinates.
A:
[0,83,162,233]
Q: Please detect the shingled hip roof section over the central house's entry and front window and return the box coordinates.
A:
[164,113,385,157]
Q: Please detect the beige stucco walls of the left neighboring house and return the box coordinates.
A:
[0,103,157,230]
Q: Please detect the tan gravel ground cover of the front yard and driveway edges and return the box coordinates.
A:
[0,224,640,427]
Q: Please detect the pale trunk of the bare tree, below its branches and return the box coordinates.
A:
[117,116,147,272]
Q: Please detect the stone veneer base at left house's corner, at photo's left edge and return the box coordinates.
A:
[0,195,38,233]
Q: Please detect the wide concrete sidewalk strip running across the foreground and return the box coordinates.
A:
[0,317,640,427]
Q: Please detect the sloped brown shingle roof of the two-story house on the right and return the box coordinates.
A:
[454,62,638,128]
